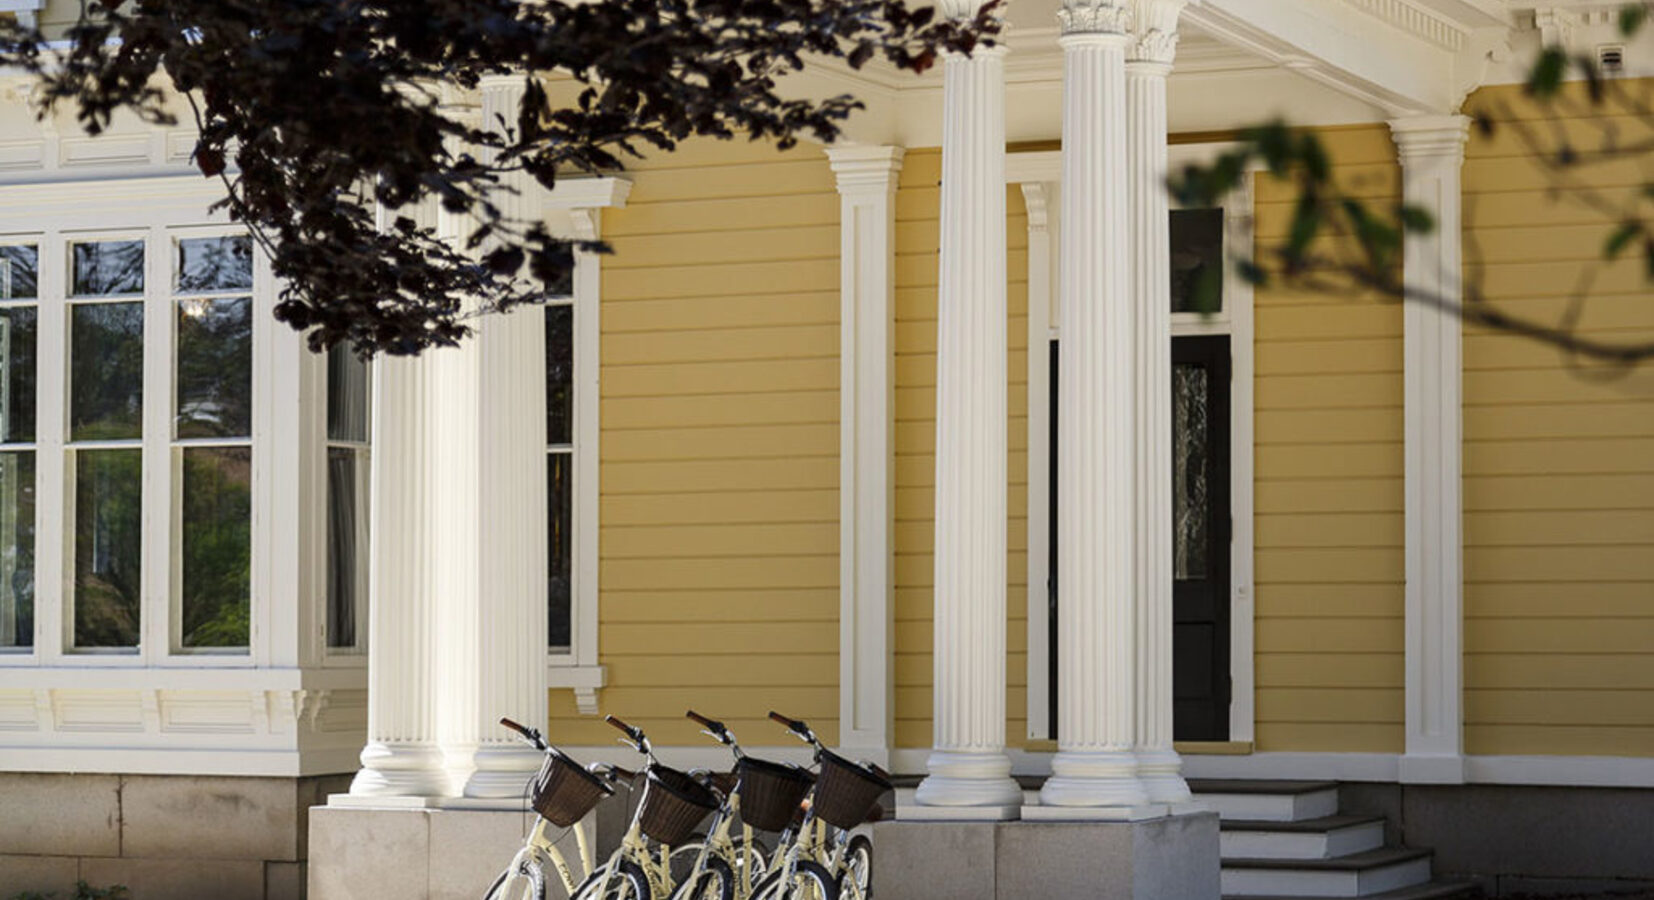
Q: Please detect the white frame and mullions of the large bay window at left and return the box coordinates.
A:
[0,177,278,668]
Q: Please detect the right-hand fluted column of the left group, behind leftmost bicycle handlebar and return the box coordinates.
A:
[465,76,547,797]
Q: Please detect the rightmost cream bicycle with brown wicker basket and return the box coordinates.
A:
[756,710,892,900]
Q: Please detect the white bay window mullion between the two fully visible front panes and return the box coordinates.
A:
[139,227,179,665]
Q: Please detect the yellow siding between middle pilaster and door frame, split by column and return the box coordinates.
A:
[895,149,1027,748]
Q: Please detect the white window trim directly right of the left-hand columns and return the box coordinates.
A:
[536,177,632,715]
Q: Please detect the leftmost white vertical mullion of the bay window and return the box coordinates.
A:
[35,232,74,665]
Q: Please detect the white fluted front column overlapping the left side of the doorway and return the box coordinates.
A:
[1024,0,1148,817]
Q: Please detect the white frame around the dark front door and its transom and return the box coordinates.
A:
[1006,142,1255,744]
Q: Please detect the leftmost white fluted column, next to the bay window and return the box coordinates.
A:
[351,340,450,797]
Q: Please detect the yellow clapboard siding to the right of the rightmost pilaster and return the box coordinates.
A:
[1464,88,1654,756]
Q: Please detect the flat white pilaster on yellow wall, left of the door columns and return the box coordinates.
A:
[827,147,903,766]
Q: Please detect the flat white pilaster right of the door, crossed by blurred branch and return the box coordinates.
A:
[1389,116,1470,784]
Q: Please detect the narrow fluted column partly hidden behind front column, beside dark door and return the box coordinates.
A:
[1126,0,1193,804]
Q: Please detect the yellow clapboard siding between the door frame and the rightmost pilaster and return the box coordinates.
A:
[1254,126,1404,753]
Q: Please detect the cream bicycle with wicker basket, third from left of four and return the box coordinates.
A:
[673,710,814,900]
